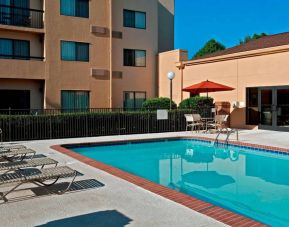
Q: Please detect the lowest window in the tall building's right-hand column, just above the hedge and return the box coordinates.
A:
[123,91,146,109]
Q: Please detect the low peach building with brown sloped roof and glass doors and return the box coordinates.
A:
[158,32,289,131]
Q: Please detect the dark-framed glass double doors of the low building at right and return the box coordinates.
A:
[258,86,289,131]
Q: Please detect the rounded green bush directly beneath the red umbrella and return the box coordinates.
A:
[179,96,214,112]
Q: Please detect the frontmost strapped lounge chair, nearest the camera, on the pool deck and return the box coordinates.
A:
[0,166,77,202]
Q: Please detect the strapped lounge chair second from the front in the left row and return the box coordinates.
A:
[0,158,58,173]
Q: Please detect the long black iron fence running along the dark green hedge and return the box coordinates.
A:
[0,107,211,141]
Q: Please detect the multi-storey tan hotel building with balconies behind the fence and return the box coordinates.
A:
[0,0,174,109]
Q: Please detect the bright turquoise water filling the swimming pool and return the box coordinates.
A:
[72,140,289,226]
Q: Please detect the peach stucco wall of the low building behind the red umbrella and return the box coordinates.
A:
[159,45,289,128]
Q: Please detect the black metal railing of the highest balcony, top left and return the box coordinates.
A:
[0,5,44,28]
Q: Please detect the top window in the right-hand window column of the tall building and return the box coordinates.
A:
[123,9,146,29]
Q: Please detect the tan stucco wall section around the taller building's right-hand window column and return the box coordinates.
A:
[112,0,158,107]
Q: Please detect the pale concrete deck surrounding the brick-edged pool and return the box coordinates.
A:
[0,130,289,227]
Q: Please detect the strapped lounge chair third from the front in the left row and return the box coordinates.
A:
[0,149,36,162]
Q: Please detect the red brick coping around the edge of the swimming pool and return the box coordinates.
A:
[51,136,276,227]
